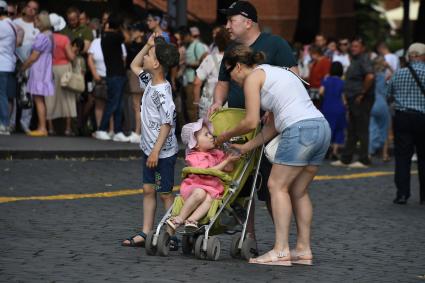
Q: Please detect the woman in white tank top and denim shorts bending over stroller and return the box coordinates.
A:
[217,45,331,266]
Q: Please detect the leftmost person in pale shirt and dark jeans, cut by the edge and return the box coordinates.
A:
[0,0,17,135]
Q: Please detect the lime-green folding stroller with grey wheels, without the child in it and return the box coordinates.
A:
[145,108,264,261]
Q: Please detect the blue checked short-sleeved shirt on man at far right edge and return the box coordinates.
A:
[387,62,425,114]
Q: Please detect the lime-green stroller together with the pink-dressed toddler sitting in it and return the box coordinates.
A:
[145,108,262,260]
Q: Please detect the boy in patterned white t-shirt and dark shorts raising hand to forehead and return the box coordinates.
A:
[122,34,179,249]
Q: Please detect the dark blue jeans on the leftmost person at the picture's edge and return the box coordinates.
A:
[0,72,16,127]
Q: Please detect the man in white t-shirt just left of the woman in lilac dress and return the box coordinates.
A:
[13,0,40,132]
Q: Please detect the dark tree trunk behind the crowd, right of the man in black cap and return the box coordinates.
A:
[294,0,322,44]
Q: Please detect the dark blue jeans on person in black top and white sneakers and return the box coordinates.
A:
[99,76,127,133]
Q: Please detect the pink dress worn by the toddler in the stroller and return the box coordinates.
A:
[180,149,226,199]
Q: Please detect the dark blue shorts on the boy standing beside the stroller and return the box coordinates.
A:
[142,153,177,194]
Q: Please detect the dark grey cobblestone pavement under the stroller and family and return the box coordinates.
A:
[0,160,425,282]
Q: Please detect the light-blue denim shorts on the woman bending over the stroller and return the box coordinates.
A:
[274,118,331,166]
